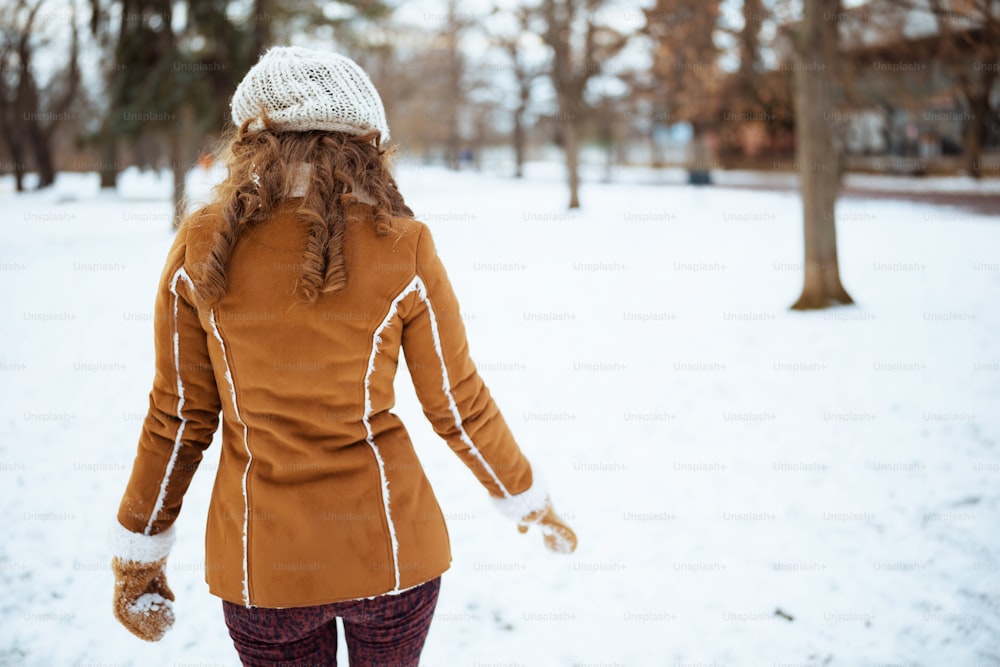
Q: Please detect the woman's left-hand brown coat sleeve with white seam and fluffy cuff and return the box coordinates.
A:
[113,227,221,560]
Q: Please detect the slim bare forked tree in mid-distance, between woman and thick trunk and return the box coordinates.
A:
[540,0,629,209]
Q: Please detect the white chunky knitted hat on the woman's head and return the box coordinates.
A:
[230,46,389,142]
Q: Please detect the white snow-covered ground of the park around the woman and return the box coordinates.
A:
[0,164,1000,667]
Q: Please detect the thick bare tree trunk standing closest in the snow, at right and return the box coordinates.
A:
[792,0,853,310]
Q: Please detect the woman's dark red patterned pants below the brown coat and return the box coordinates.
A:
[222,577,441,667]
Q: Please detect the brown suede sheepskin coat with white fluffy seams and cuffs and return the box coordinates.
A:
[118,200,546,607]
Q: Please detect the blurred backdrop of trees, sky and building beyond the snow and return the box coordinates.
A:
[0,0,1000,204]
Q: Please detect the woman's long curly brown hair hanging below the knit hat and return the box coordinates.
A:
[188,121,413,306]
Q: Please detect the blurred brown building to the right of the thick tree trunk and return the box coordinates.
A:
[830,0,1000,171]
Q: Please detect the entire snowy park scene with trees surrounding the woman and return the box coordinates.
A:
[0,0,1000,667]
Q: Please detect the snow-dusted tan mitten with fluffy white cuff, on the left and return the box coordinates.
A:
[111,526,174,642]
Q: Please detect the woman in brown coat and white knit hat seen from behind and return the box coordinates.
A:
[107,47,576,665]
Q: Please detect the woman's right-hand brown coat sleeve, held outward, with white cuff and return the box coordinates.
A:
[402,228,548,519]
